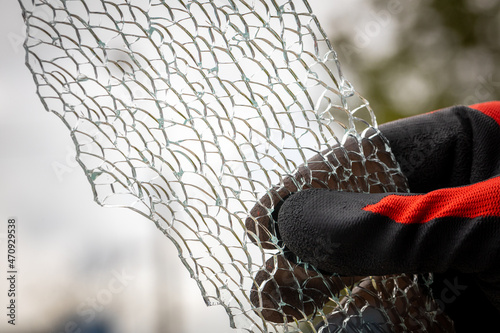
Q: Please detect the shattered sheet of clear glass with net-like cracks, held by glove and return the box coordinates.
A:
[20,0,449,332]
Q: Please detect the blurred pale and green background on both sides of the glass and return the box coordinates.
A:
[0,0,500,333]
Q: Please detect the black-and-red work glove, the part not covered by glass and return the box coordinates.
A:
[247,102,500,330]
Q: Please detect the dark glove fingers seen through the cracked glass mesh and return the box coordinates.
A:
[246,119,418,327]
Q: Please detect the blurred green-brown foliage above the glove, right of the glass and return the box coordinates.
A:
[329,0,500,123]
